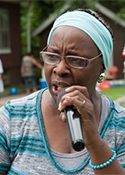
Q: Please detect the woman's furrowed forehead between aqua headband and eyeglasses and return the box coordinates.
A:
[50,26,97,53]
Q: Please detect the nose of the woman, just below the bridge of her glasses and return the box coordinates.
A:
[53,59,70,77]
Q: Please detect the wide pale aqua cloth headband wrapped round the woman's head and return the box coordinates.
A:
[47,11,113,68]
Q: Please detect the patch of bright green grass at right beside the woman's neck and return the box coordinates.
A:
[101,86,125,100]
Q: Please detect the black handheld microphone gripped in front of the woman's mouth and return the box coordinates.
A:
[57,87,85,151]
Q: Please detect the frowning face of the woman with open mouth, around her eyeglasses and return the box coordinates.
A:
[44,26,103,99]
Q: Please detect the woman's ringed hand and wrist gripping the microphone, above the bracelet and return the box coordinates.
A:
[58,86,101,147]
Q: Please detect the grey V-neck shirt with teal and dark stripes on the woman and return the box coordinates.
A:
[0,90,125,175]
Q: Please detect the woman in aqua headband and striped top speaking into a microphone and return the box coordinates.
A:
[0,10,125,175]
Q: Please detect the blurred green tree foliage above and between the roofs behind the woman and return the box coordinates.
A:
[21,0,125,71]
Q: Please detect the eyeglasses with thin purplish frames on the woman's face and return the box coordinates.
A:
[40,51,101,69]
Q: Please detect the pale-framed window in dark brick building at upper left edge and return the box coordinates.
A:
[0,9,11,54]
